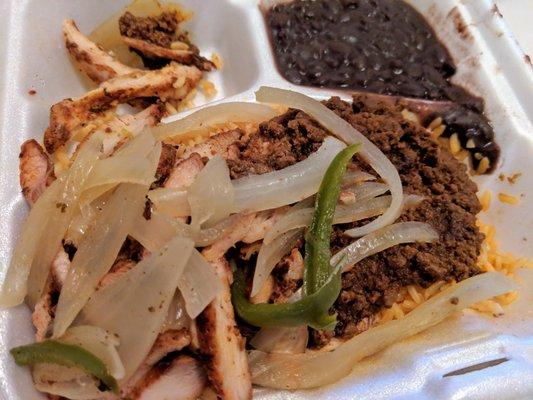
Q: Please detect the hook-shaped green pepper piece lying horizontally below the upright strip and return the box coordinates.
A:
[231,269,341,330]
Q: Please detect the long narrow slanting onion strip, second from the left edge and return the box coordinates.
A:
[28,134,102,307]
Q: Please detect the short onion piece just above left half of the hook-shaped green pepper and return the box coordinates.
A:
[250,229,303,297]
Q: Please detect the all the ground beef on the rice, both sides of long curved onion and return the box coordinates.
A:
[230,98,483,347]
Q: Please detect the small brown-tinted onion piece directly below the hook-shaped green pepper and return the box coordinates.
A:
[250,326,309,354]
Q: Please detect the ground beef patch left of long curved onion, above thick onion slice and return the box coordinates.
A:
[228,110,327,179]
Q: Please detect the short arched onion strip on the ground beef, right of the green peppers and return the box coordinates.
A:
[331,221,439,272]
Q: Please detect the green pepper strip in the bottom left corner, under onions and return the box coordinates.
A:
[10,340,118,394]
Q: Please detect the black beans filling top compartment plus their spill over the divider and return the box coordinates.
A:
[265,0,499,171]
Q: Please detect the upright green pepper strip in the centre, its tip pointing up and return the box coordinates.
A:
[303,144,360,295]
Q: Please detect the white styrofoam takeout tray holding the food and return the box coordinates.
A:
[0,0,533,400]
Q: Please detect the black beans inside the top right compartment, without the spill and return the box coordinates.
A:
[267,0,454,100]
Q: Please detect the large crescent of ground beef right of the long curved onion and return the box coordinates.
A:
[311,98,483,346]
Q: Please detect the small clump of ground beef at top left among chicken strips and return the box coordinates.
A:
[118,11,179,48]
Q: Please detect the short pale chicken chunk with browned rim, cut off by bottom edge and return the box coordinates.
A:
[132,356,207,400]
